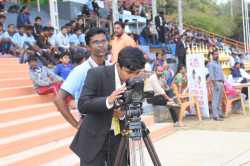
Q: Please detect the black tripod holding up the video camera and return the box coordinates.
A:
[114,116,161,166]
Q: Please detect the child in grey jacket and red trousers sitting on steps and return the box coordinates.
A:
[27,55,75,109]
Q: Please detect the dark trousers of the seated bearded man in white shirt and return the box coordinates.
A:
[147,90,179,123]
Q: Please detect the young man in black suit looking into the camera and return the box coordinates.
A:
[70,47,146,166]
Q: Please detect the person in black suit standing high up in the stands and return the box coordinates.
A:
[155,11,166,43]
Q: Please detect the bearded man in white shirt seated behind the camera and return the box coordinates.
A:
[146,66,184,127]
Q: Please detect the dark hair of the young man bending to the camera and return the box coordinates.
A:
[118,47,146,71]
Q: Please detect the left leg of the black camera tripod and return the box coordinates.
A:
[114,136,128,166]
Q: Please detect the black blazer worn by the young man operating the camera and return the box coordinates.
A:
[70,65,125,162]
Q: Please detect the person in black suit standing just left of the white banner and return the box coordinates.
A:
[175,35,186,66]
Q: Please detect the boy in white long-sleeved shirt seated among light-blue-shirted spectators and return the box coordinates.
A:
[55,26,70,52]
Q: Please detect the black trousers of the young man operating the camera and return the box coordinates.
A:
[80,132,128,166]
